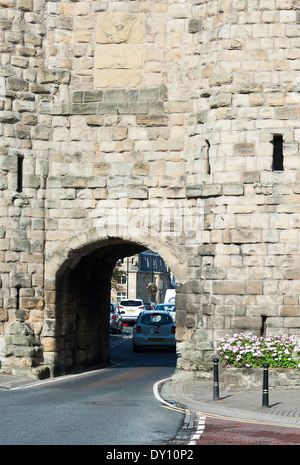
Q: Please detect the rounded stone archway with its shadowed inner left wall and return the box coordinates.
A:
[41,227,186,376]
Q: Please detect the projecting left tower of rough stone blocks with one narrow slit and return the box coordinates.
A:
[0,0,47,373]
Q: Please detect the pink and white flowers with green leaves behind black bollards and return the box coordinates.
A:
[217,333,300,369]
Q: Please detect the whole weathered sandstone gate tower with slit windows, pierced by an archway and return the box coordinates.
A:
[0,0,300,379]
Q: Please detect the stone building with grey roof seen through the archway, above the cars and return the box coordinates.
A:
[111,250,175,304]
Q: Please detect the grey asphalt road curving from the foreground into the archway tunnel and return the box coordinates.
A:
[0,327,183,445]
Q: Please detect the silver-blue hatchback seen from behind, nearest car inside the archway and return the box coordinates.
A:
[133,310,176,352]
